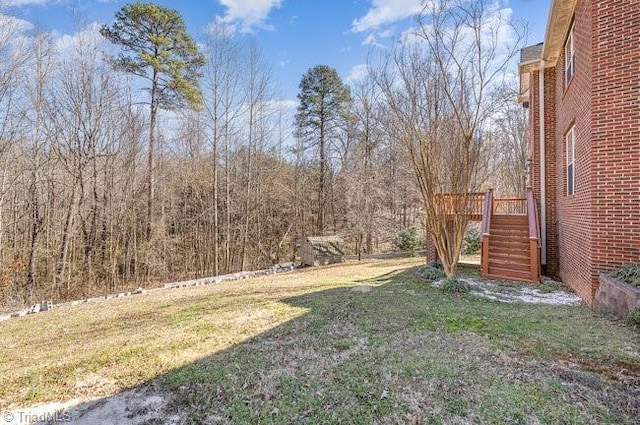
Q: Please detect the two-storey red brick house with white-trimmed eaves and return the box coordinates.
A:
[519,0,640,304]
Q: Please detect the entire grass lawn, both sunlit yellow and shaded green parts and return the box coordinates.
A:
[0,259,640,424]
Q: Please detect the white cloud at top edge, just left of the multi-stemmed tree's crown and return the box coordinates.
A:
[351,0,422,32]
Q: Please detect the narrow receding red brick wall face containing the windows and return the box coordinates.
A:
[547,0,597,303]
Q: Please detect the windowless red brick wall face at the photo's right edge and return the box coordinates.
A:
[591,0,640,278]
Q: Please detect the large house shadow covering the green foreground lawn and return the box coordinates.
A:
[41,268,640,424]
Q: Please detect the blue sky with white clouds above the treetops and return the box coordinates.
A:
[0,0,550,99]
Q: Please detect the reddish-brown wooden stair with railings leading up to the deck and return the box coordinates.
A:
[482,188,540,282]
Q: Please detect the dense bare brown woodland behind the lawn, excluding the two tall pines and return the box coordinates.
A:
[0,1,527,306]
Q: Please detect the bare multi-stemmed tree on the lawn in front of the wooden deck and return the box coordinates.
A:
[375,0,521,276]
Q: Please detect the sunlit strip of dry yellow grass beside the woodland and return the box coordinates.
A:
[0,259,419,411]
